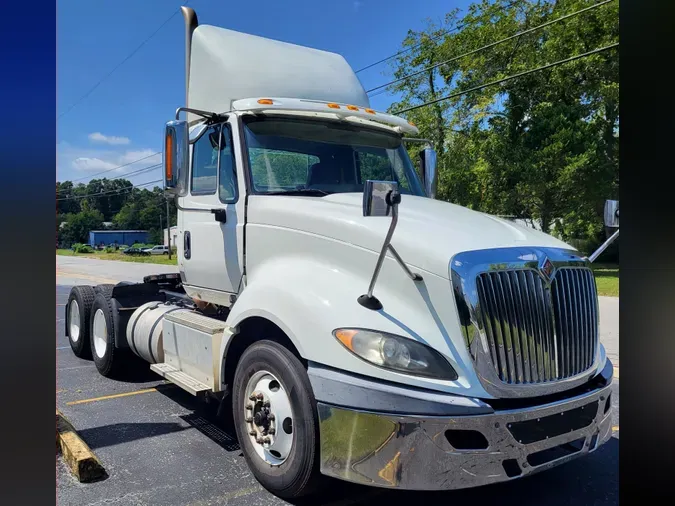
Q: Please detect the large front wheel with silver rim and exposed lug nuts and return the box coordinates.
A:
[232,341,322,499]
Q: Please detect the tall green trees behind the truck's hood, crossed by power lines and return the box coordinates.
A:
[389,0,619,244]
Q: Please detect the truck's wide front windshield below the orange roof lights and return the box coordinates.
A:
[245,117,424,196]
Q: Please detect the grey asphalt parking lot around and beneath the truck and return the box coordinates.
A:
[56,257,619,506]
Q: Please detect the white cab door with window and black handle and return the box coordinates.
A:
[178,122,243,298]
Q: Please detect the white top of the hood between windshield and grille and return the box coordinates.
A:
[248,193,573,278]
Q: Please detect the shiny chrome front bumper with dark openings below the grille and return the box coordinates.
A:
[310,361,612,490]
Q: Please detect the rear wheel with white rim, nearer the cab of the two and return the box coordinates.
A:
[90,291,125,377]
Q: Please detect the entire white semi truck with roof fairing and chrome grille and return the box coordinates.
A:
[66,7,618,498]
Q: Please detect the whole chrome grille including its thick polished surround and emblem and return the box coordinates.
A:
[449,247,598,398]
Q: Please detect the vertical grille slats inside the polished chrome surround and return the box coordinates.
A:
[476,267,597,384]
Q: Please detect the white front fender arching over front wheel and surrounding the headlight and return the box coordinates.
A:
[227,251,490,398]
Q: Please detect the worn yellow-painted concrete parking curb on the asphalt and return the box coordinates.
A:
[56,409,106,483]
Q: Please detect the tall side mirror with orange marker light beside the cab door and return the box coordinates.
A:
[164,120,189,197]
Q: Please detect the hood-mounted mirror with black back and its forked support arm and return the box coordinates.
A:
[357,180,422,311]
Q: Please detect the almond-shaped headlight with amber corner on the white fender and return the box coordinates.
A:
[333,329,457,380]
